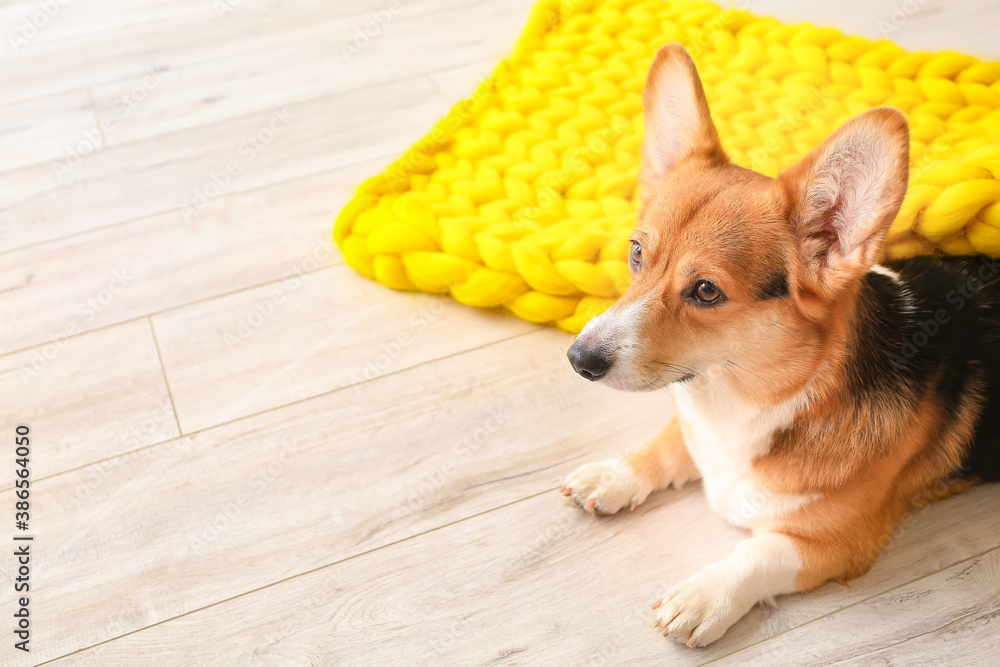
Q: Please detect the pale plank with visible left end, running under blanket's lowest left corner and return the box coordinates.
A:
[153,265,536,433]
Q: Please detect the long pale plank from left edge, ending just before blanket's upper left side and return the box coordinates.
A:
[0,77,447,249]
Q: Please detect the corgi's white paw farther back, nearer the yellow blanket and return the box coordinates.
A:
[560,458,653,514]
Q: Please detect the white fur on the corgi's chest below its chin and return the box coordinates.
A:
[672,384,812,528]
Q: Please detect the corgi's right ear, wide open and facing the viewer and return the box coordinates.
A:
[778,107,910,298]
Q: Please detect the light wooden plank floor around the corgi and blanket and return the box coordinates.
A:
[0,0,1000,666]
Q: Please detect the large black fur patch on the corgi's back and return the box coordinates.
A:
[848,257,1000,481]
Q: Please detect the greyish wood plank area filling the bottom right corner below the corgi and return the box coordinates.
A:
[713,549,1000,665]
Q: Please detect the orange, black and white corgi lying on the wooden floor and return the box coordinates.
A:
[561,44,1000,646]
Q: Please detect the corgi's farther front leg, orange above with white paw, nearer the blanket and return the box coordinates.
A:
[561,418,701,514]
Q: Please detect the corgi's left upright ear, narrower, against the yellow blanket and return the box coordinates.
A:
[639,43,727,192]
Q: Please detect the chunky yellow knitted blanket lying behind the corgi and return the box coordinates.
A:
[334,0,1000,332]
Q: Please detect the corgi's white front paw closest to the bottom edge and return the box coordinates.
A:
[653,563,754,647]
